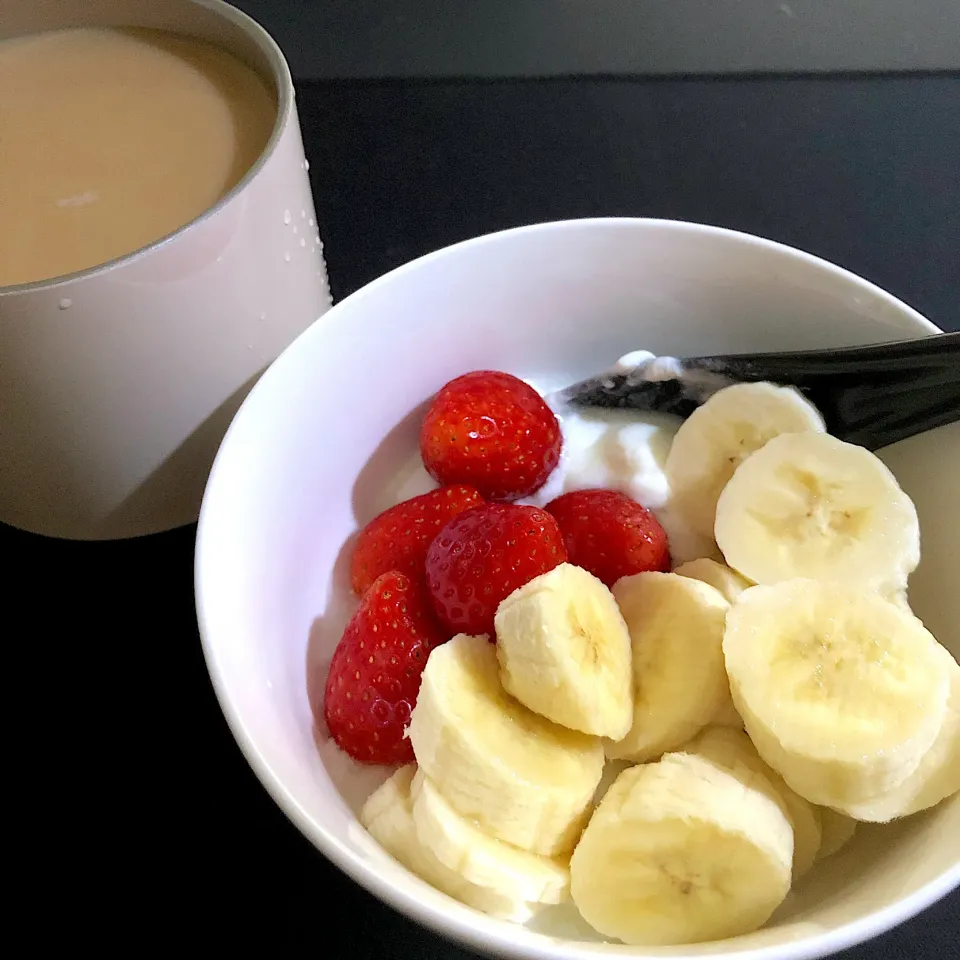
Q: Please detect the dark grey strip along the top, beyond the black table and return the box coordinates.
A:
[232,0,960,80]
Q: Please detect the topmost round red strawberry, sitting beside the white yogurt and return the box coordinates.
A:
[420,370,563,500]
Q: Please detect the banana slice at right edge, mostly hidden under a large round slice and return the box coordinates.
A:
[845,647,960,823]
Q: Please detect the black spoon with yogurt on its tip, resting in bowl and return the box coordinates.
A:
[560,333,960,450]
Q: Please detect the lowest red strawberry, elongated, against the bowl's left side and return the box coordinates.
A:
[323,570,447,764]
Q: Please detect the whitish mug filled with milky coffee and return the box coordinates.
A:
[0,0,330,539]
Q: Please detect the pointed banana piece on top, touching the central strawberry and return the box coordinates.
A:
[495,563,633,740]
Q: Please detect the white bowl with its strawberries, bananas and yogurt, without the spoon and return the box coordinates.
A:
[197,220,960,960]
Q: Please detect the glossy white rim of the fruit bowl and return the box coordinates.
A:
[194,217,960,960]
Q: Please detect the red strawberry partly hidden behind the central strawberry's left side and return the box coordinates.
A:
[350,486,483,597]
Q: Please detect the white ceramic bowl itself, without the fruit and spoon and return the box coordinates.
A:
[196,219,960,960]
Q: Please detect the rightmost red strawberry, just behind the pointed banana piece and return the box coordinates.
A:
[546,490,670,587]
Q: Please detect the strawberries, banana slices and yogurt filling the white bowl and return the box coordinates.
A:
[320,370,960,946]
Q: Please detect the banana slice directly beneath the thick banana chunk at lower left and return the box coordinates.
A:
[410,770,570,903]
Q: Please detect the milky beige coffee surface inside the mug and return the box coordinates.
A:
[0,28,277,287]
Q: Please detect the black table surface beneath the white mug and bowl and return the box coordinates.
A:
[9,75,960,960]
